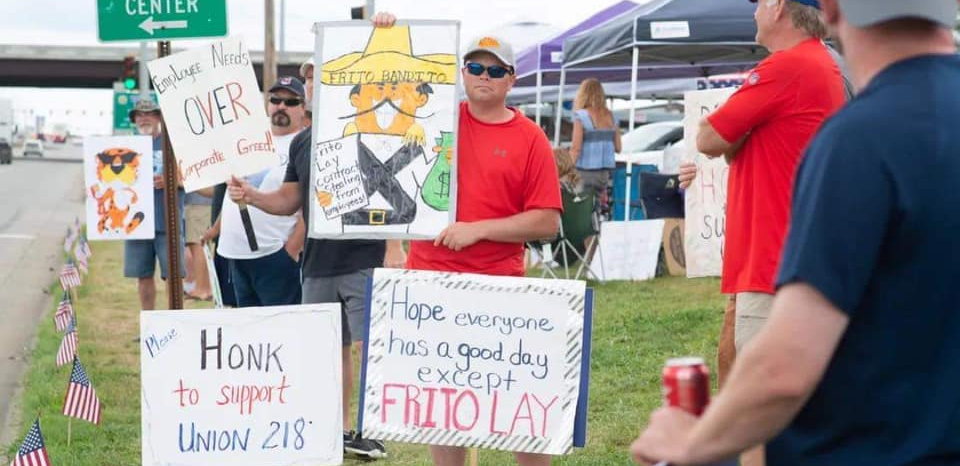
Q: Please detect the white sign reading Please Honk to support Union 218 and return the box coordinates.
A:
[140,304,343,466]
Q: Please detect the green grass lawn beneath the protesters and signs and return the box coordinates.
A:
[5,243,724,466]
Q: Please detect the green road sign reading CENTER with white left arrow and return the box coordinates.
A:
[97,0,227,42]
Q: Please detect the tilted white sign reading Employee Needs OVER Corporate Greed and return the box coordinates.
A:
[147,39,280,192]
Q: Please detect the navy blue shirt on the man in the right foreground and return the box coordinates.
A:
[767,55,960,466]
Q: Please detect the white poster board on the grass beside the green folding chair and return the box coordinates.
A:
[593,219,664,281]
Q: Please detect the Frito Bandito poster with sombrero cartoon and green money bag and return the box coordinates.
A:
[309,21,460,239]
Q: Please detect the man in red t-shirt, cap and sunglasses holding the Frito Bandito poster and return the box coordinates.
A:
[407,37,563,466]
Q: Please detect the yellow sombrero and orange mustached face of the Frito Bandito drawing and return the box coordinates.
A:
[320,26,457,146]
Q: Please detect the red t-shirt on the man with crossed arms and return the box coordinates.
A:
[708,39,844,294]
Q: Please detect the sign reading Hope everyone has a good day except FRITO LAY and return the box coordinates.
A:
[361,269,591,454]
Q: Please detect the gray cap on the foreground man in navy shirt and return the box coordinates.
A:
[838,0,957,29]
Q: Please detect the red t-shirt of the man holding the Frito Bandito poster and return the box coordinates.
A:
[407,102,563,276]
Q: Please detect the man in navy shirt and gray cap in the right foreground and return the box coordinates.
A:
[631,0,960,466]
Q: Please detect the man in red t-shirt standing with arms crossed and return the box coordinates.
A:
[681,0,845,466]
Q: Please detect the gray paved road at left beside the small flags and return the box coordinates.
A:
[0,145,83,445]
